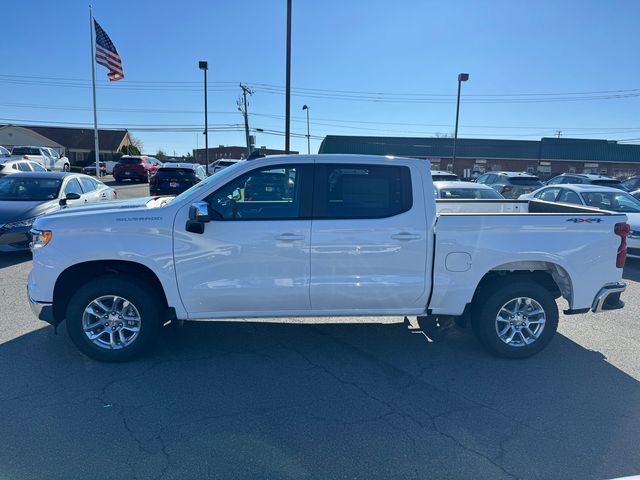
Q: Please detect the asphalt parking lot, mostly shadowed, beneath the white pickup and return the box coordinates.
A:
[0,184,640,479]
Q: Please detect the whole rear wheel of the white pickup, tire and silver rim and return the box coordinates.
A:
[471,278,558,358]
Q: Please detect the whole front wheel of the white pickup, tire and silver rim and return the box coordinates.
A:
[66,275,161,362]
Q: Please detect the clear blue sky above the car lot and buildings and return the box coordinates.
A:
[0,0,640,154]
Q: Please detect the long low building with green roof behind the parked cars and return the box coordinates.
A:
[318,135,640,179]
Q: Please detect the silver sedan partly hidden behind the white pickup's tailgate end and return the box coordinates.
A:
[520,184,640,258]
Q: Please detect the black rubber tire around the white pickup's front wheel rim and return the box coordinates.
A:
[66,275,164,362]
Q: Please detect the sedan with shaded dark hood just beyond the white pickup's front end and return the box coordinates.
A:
[0,172,115,252]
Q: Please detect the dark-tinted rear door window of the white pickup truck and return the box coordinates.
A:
[314,164,412,219]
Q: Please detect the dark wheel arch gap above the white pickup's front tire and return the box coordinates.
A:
[53,260,169,324]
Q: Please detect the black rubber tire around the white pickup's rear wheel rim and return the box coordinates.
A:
[471,277,558,358]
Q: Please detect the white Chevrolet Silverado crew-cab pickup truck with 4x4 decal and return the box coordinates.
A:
[28,155,628,361]
